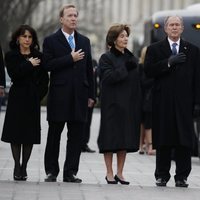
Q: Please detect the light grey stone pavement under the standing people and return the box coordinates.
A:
[0,108,200,200]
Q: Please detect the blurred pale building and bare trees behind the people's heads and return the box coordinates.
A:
[0,0,200,60]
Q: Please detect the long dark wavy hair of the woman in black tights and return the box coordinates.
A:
[9,24,40,51]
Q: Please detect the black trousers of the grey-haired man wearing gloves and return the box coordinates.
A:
[155,146,192,181]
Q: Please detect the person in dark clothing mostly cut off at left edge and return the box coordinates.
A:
[0,46,6,111]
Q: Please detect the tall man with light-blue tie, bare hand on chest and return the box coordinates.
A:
[43,5,94,183]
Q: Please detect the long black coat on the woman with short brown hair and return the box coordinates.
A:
[98,48,141,153]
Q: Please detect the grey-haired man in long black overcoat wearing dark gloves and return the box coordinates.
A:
[145,16,200,187]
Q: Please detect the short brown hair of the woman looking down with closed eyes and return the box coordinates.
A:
[106,24,130,47]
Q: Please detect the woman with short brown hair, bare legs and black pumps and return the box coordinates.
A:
[98,24,141,184]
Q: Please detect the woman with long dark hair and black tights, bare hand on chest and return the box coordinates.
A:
[1,25,49,180]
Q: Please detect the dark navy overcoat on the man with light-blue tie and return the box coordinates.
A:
[43,29,94,121]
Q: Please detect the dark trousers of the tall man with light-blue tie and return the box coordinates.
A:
[44,121,84,178]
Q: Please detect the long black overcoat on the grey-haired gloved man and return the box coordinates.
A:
[145,39,200,148]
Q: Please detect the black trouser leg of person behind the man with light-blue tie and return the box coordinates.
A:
[82,107,93,149]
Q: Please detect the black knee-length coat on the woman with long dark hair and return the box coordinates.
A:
[1,50,49,144]
